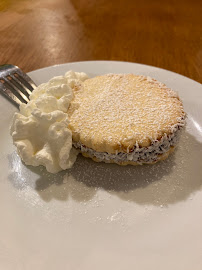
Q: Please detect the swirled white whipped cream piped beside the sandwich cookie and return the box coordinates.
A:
[10,71,88,173]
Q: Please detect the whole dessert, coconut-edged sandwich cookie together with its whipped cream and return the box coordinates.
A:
[10,71,185,173]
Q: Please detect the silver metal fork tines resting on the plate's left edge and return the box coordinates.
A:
[0,64,36,107]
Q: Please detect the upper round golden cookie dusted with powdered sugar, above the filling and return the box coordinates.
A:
[69,74,184,153]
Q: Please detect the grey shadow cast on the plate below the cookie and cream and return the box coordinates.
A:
[9,132,202,205]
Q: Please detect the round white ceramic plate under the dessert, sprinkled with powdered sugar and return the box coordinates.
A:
[0,61,202,270]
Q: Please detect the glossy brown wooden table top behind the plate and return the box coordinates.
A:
[0,0,202,82]
